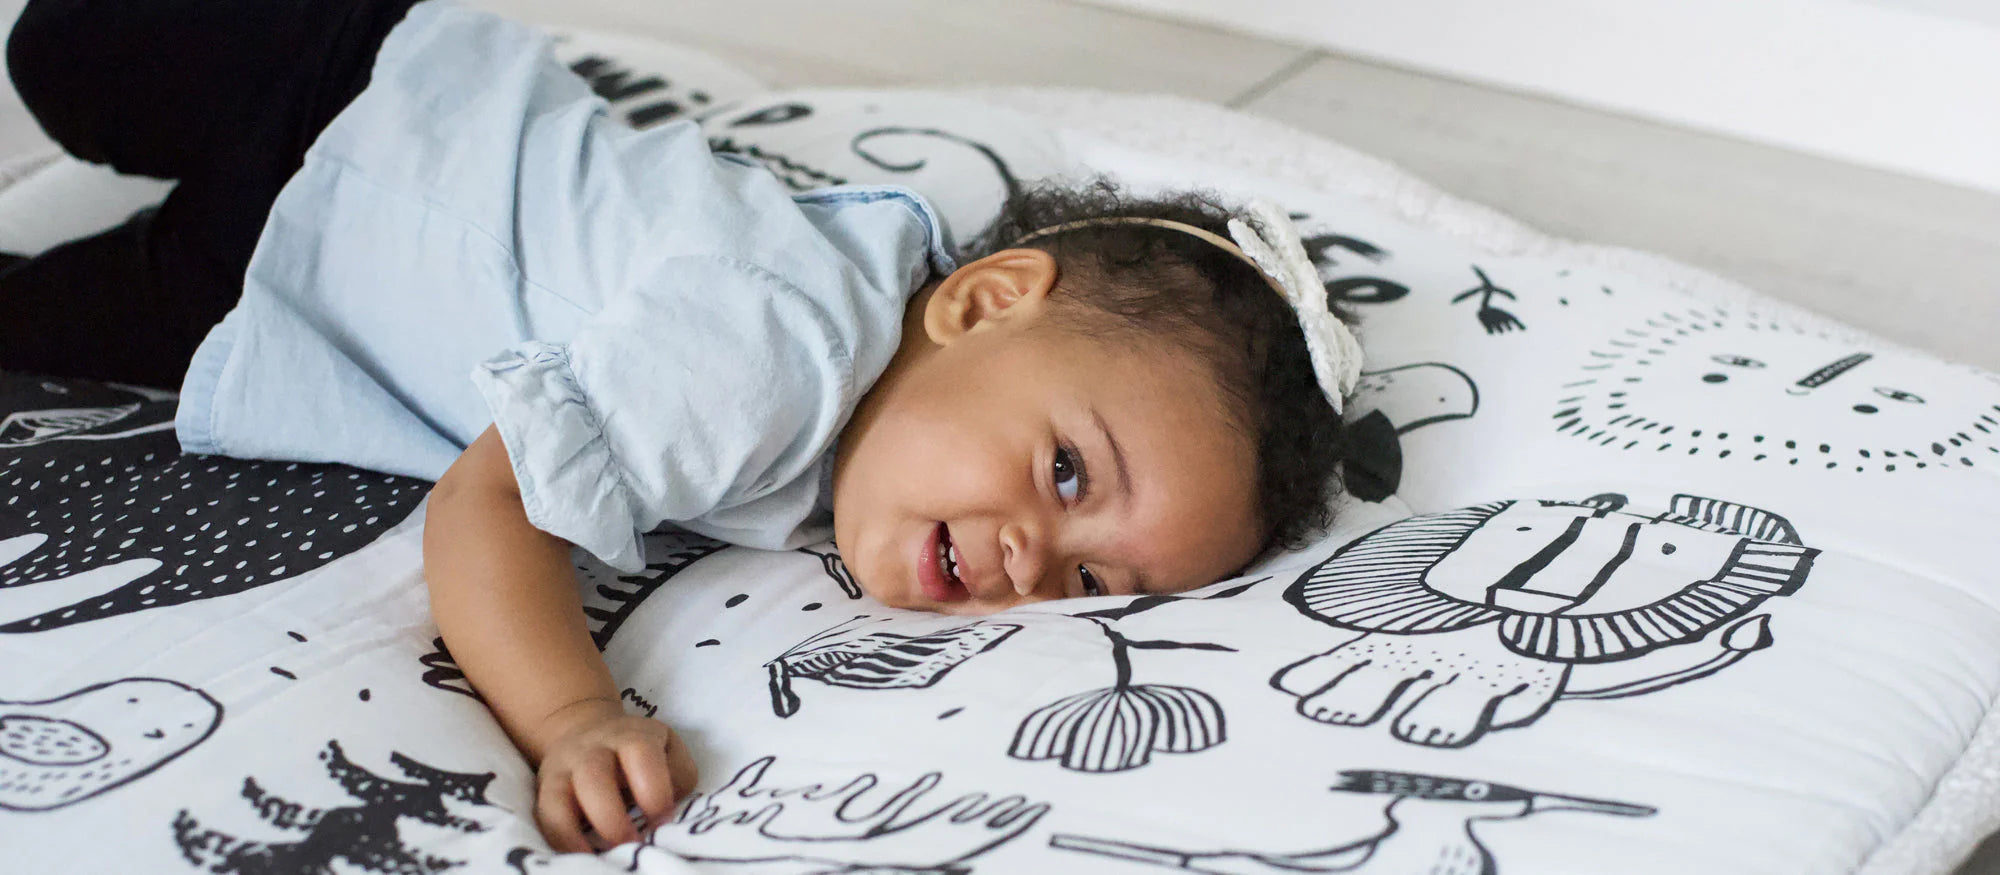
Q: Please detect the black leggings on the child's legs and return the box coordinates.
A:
[0,0,418,388]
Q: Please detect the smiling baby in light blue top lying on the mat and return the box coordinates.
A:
[0,0,1360,851]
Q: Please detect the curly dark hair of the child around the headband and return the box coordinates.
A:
[960,178,1354,555]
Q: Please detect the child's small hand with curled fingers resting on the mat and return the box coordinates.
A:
[534,699,696,851]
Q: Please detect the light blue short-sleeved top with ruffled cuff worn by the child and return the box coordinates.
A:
[176,0,952,571]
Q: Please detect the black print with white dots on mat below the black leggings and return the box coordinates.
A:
[0,374,430,631]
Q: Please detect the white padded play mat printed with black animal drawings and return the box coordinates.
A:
[0,15,2000,875]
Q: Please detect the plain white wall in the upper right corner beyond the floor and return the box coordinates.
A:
[1088,0,2000,192]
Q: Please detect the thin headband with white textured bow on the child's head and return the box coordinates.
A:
[1010,200,1362,414]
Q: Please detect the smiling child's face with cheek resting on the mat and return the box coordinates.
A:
[834,259,1260,613]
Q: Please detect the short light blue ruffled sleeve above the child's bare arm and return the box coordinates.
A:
[472,256,880,571]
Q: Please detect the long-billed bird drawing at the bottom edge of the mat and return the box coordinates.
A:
[1048,769,1658,875]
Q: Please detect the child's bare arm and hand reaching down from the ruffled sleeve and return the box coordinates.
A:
[424,428,694,851]
